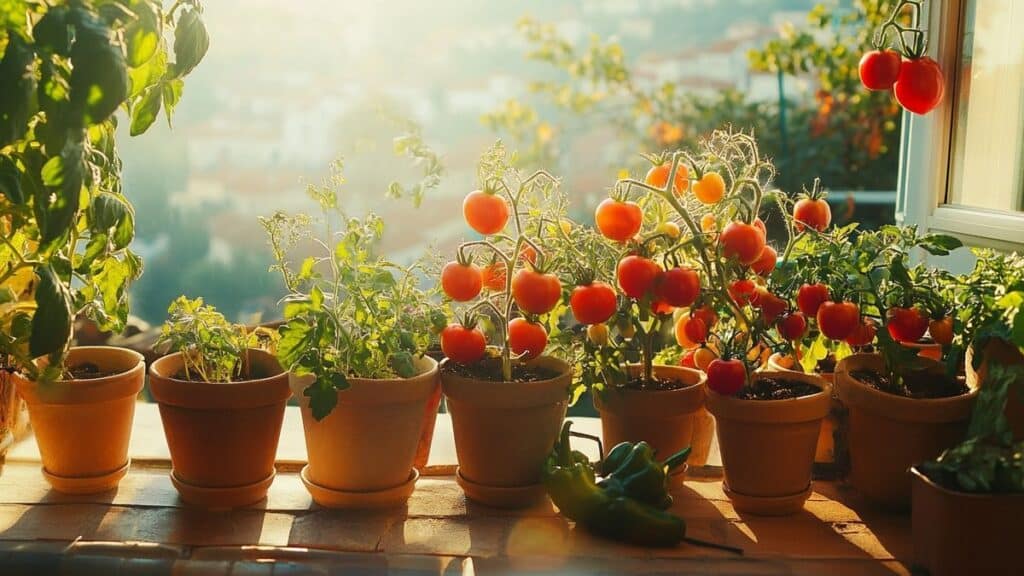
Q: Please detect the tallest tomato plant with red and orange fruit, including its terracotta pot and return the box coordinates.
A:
[598,131,830,515]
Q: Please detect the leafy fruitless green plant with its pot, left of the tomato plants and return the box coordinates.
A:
[261,163,445,508]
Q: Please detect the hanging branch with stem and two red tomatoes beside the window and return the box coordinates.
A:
[859,0,945,115]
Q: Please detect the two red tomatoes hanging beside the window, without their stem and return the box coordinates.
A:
[859,49,945,115]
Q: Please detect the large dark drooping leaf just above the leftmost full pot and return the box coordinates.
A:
[29,265,72,358]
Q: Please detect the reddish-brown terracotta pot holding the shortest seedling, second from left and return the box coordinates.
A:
[150,349,291,508]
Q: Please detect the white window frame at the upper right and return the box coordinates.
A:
[896,0,1024,251]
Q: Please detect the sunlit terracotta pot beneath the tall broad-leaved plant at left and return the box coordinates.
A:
[12,346,145,494]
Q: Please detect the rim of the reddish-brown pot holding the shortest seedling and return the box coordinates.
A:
[150,348,292,410]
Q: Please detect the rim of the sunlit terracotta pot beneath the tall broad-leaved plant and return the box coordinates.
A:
[11,346,145,404]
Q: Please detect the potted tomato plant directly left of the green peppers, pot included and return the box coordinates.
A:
[440,142,572,507]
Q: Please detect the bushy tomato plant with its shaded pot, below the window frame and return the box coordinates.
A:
[798,227,975,507]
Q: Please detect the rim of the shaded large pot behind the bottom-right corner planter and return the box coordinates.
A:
[836,354,978,422]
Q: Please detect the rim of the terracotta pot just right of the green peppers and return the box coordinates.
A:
[708,370,831,424]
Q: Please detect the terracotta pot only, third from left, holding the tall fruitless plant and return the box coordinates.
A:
[290,357,440,508]
